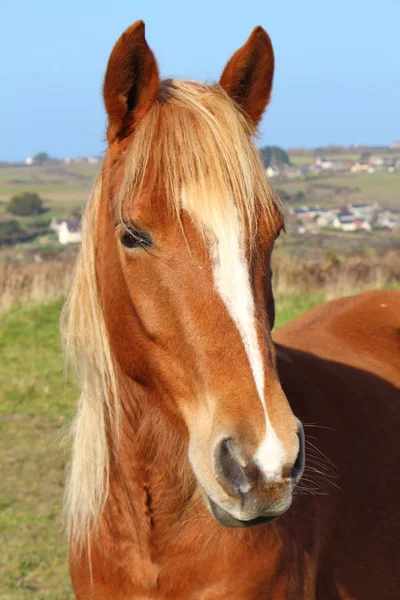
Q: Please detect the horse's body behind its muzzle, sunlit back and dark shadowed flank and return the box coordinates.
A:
[275,291,400,600]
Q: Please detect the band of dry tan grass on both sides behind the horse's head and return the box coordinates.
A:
[0,251,400,311]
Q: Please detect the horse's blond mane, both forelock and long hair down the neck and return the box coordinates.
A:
[62,80,279,545]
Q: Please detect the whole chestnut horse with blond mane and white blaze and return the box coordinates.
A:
[62,21,400,600]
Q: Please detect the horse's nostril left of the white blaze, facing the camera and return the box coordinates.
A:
[214,438,249,494]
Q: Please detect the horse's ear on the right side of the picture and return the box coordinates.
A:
[219,26,274,127]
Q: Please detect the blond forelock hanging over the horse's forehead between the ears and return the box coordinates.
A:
[117,80,279,246]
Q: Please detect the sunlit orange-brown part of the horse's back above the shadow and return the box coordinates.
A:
[274,291,400,386]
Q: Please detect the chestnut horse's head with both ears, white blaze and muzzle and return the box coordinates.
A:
[96,23,304,527]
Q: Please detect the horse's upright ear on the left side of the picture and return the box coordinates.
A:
[103,21,160,143]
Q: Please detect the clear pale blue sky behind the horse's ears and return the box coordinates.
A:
[0,0,400,160]
